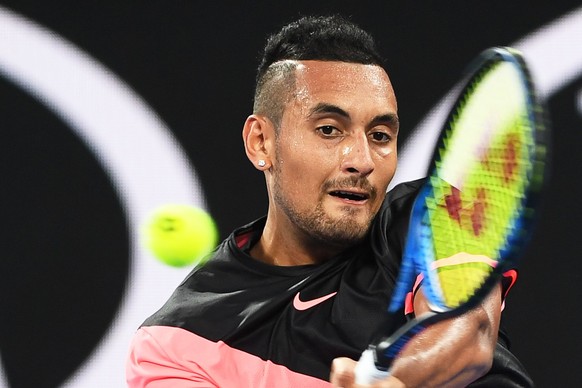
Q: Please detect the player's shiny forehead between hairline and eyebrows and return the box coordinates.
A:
[295,61,396,111]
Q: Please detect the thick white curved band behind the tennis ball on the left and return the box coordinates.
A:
[0,7,204,387]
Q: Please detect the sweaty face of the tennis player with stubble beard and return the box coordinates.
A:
[270,61,398,246]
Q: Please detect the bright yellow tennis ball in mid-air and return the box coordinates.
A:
[144,204,218,267]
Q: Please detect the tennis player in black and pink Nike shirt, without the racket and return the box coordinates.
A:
[127,16,532,388]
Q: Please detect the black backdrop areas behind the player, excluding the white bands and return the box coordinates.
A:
[0,0,582,387]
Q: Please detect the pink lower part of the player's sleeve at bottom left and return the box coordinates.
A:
[126,326,331,388]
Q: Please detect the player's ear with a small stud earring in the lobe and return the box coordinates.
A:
[242,115,275,171]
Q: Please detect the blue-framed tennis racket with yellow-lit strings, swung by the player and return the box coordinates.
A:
[356,47,549,384]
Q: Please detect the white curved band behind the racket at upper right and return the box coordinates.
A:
[390,7,582,188]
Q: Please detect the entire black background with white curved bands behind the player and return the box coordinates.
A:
[0,0,582,388]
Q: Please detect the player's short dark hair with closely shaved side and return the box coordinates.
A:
[253,15,384,127]
